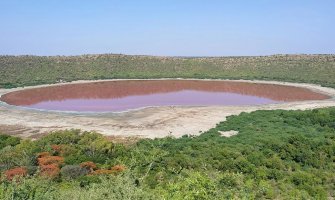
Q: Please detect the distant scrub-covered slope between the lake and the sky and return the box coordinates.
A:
[0,54,335,87]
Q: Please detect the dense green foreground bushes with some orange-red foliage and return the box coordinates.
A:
[0,108,335,200]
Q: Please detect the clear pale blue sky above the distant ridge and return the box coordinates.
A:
[0,0,335,56]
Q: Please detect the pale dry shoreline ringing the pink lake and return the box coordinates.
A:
[0,79,335,138]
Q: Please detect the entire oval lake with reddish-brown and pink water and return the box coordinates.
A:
[1,80,328,111]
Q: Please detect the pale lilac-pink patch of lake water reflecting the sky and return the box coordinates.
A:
[29,90,278,112]
